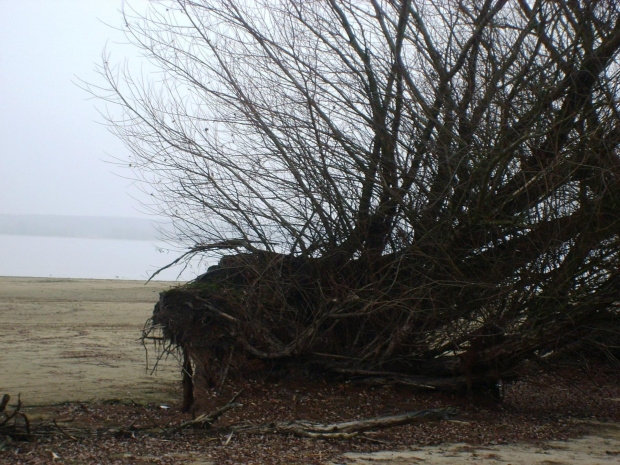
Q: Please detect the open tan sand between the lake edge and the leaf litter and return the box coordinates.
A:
[0,277,180,405]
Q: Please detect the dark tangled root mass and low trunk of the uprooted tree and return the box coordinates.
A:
[144,239,620,409]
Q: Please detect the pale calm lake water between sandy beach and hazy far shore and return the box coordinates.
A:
[0,235,208,281]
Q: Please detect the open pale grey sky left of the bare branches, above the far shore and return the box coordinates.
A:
[0,0,146,217]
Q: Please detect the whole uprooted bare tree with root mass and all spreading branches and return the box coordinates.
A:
[98,0,620,406]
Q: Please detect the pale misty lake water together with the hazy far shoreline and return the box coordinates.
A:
[0,215,201,281]
